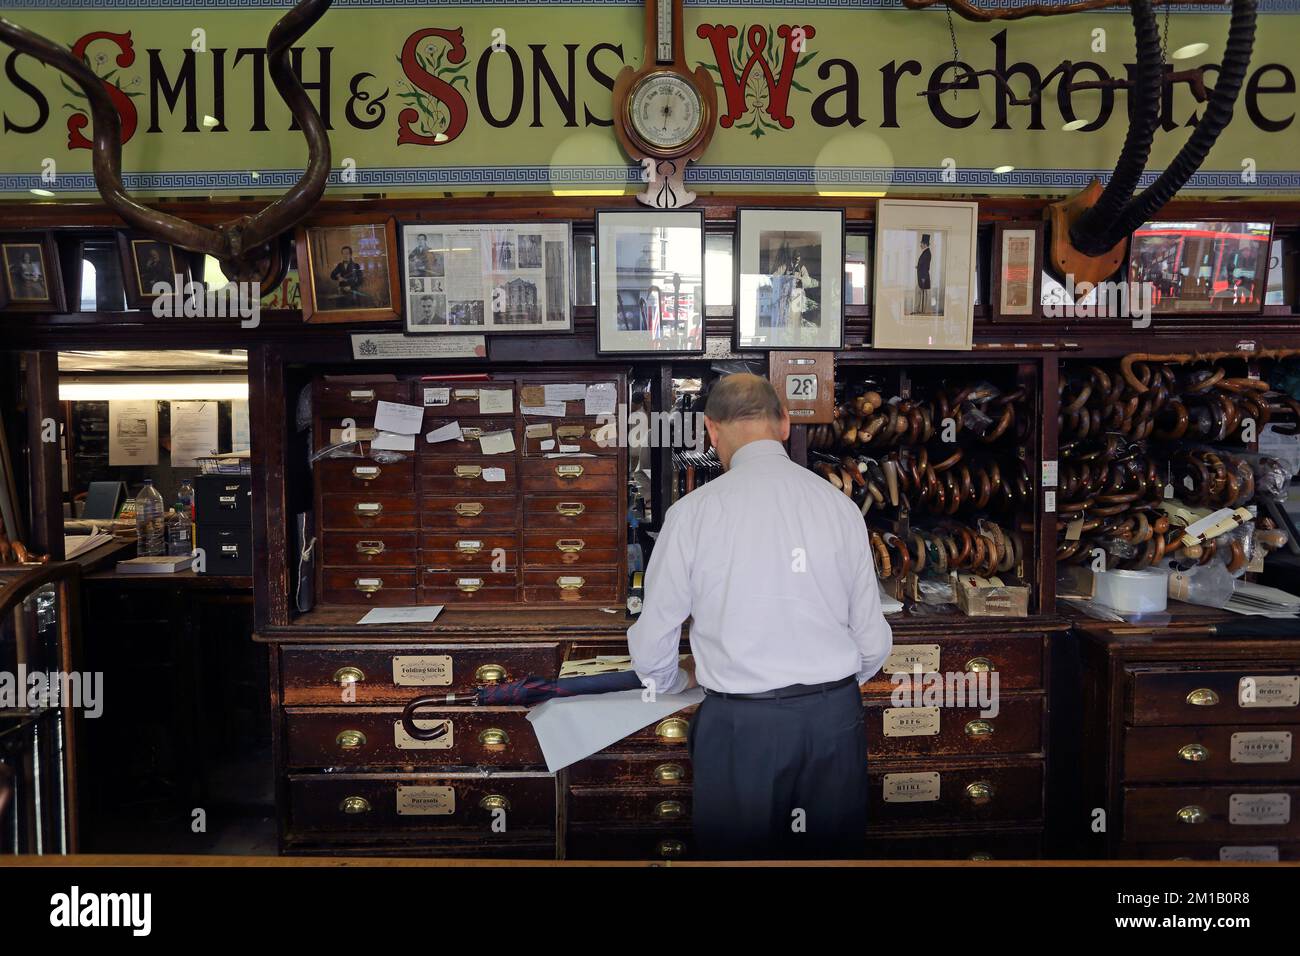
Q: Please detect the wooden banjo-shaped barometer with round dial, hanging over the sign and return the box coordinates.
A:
[614,0,718,209]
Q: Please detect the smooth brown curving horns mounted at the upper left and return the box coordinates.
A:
[0,0,332,285]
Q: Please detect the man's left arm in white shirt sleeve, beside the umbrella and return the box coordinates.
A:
[628,503,694,693]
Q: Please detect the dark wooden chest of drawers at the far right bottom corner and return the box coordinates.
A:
[1080,615,1300,861]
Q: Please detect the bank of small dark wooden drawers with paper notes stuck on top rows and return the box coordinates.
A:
[315,372,627,607]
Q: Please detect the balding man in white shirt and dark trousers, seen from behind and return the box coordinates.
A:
[628,375,892,858]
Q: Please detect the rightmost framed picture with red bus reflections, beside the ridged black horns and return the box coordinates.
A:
[1128,221,1273,315]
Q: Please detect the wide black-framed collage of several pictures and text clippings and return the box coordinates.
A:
[402,222,573,333]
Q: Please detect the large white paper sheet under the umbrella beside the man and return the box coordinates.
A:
[528,687,705,773]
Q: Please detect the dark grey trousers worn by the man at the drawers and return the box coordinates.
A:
[690,683,867,860]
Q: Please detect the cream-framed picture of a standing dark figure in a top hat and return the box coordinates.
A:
[871,199,979,349]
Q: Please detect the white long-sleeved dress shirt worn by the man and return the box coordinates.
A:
[628,440,893,693]
